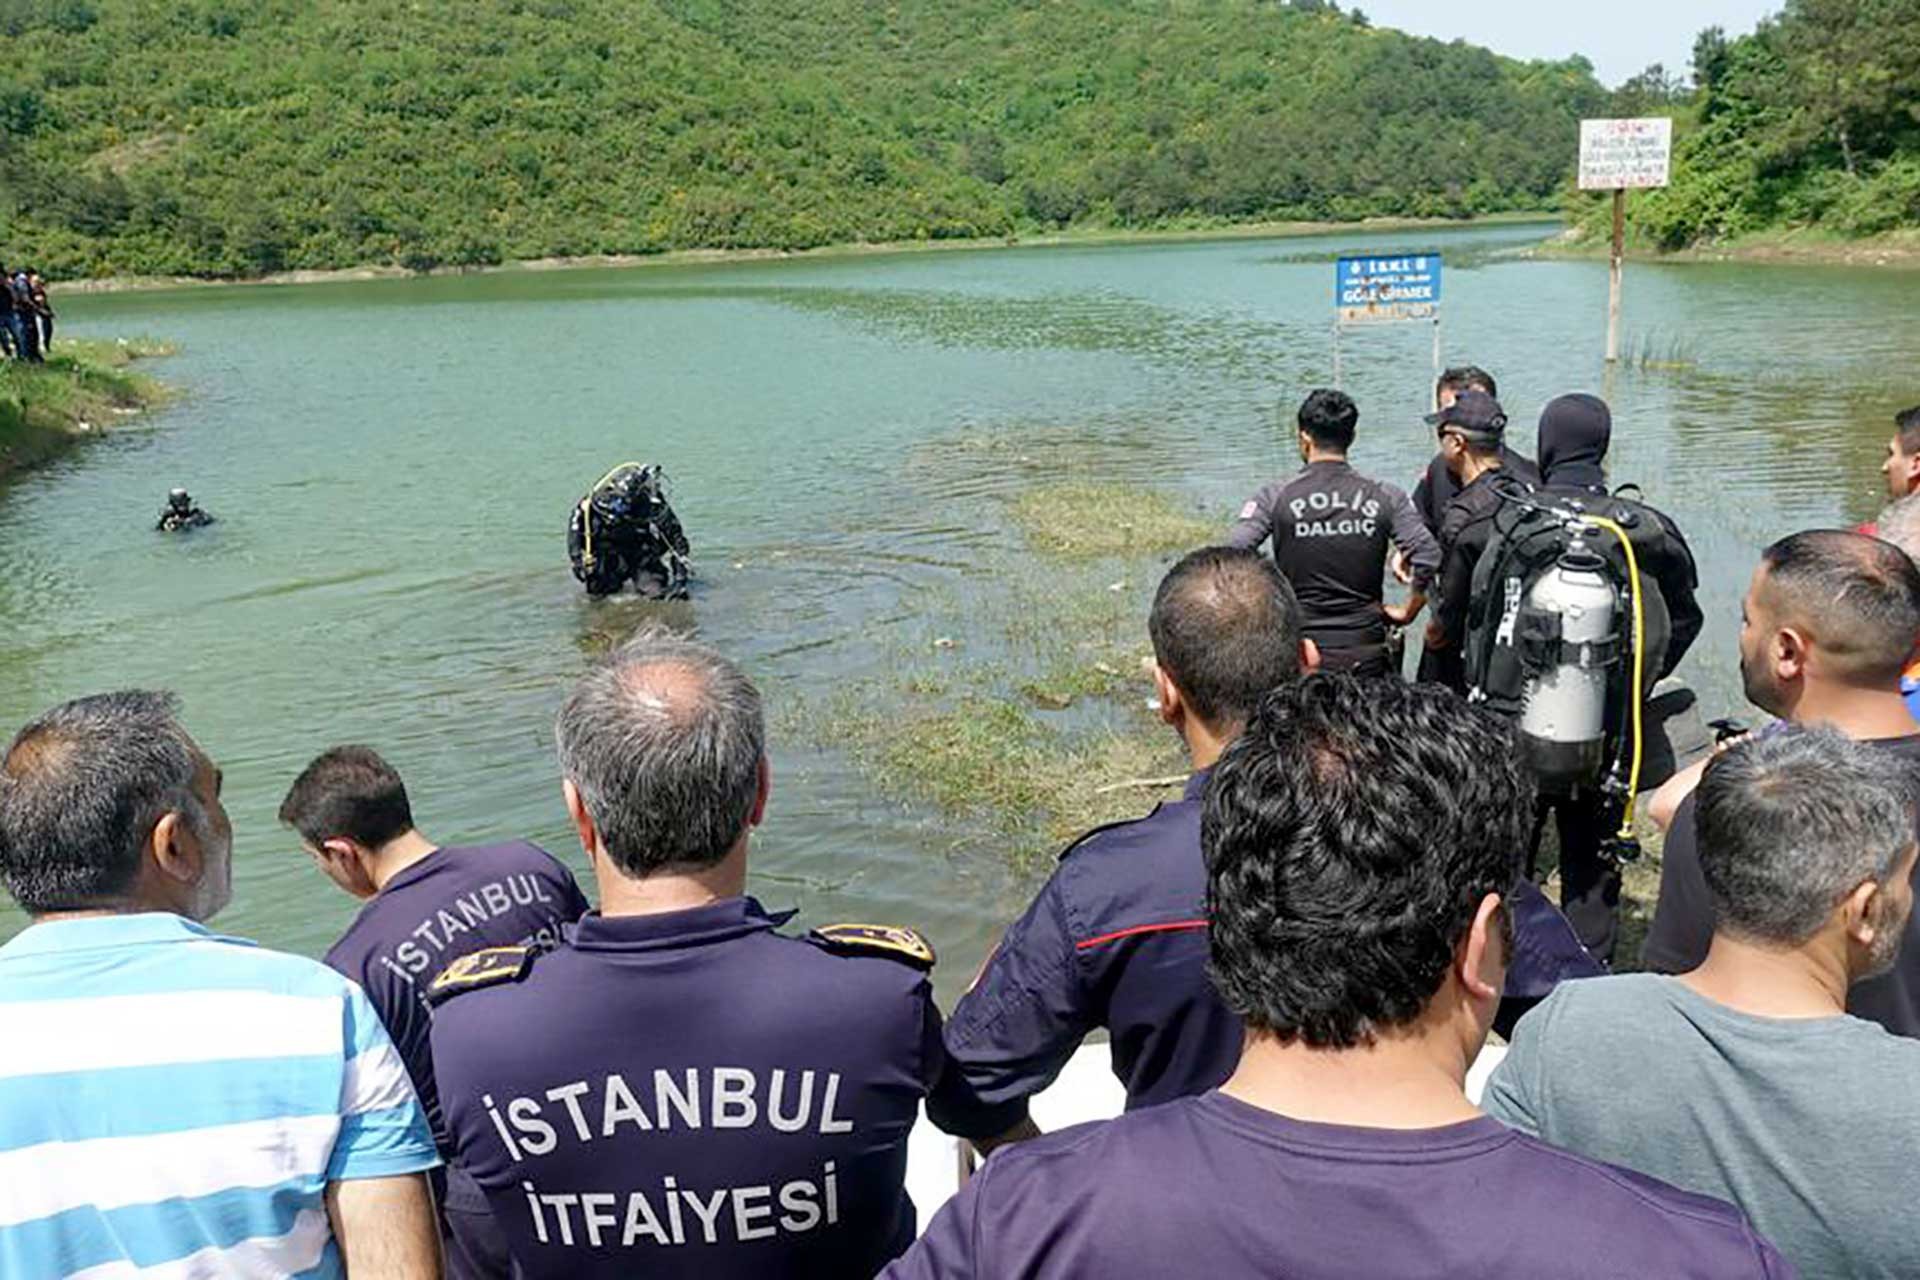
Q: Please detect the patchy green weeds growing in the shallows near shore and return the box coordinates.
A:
[789,482,1215,873]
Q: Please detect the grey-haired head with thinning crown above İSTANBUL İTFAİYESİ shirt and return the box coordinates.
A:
[555,629,766,877]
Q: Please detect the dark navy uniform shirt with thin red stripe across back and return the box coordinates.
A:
[927,770,1603,1138]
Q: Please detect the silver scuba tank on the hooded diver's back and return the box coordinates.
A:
[1515,539,1620,791]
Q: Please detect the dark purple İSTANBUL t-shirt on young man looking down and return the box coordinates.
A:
[326,841,589,1151]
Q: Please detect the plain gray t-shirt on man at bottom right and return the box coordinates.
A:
[1482,973,1920,1280]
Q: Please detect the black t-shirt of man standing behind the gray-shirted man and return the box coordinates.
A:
[1640,735,1920,1038]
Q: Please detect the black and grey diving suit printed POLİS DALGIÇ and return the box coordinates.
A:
[1227,461,1440,676]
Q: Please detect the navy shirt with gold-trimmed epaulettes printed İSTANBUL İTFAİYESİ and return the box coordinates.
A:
[434,898,945,1280]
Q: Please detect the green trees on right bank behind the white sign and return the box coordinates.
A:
[1582,0,1920,249]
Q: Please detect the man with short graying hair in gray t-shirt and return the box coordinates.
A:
[1482,727,1920,1280]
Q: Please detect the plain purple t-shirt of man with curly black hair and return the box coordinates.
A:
[881,1092,1795,1280]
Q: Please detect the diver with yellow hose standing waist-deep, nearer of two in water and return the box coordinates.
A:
[566,462,693,601]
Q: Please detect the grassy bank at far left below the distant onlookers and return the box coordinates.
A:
[0,338,173,474]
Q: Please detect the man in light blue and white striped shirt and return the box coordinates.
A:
[0,691,440,1280]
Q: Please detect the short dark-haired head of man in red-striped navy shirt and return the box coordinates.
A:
[1146,547,1300,729]
